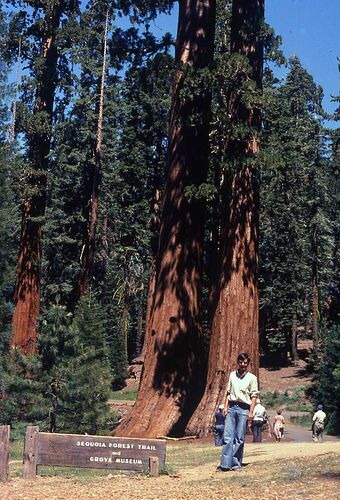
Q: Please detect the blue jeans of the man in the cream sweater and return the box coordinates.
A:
[221,404,249,469]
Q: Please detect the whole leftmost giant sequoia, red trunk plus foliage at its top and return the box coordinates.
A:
[11,0,76,353]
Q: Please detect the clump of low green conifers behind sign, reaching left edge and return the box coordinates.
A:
[0,297,117,435]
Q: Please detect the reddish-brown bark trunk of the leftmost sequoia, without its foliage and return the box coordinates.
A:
[10,1,63,354]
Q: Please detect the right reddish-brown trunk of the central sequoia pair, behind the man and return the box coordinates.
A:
[186,0,264,435]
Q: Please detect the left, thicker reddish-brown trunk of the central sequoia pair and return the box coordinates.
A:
[115,0,215,437]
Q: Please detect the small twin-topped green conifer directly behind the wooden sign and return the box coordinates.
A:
[41,296,113,434]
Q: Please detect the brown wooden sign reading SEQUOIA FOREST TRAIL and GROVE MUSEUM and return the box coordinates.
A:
[24,426,165,479]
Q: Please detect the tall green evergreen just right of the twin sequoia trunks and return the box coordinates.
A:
[260,58,333,362]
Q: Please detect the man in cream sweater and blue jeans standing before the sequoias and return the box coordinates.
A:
[217,352,258,472]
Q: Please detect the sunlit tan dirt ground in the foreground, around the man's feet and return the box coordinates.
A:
[0,441,340,500]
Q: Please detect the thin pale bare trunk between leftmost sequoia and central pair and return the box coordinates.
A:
[79,11,109,297]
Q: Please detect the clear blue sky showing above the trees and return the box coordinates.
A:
[154,0,340,118]
